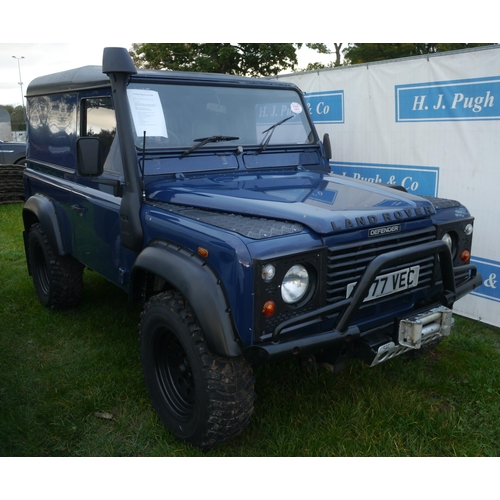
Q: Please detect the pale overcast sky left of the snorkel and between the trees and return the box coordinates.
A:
[0,42,335,106]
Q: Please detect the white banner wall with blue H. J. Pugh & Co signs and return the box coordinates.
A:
[278,46,500,326]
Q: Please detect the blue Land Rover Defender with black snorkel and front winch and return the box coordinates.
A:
[23,48,481,448]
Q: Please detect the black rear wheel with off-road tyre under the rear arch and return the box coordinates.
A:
[28,224,83,310]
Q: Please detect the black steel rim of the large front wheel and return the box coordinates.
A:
[155,329,195,419]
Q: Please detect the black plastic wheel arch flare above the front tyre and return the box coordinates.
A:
[130,241,243,357]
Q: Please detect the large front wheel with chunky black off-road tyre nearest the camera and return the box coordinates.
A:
[139,292,255,449]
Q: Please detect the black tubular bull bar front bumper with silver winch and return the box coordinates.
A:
[244,240,482,365]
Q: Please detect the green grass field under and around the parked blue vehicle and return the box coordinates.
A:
[0,204,500,457]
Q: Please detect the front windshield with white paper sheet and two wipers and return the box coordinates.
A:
[128,83,314,150]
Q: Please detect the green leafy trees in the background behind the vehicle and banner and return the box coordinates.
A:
[4,43,494,131]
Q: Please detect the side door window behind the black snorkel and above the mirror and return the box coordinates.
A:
[80,97,116,165]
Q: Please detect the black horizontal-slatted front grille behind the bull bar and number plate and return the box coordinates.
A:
[327,227,436,319]
